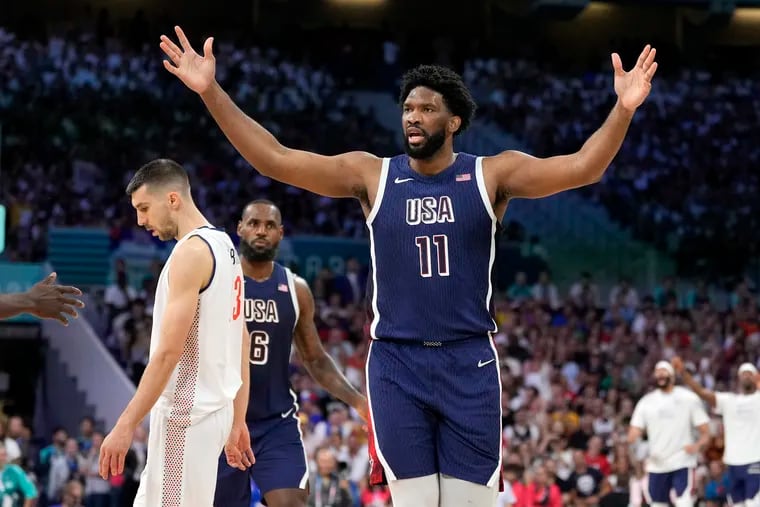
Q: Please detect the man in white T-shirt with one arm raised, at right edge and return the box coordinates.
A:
[672,357,760,507]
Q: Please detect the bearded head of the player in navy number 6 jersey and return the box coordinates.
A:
[238,204,283,262]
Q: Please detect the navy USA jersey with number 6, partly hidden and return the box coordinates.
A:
[245,263,298,422]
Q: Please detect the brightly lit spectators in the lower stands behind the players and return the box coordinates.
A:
[0,262,760,507]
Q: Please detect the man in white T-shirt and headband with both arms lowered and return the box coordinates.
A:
[628,361,710,507]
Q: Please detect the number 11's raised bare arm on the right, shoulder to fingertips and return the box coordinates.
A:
[490,45,657,198]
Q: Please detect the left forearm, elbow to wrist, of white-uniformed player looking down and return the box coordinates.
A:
[117,351,179,428]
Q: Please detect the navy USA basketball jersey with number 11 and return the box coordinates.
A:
[367,153,498,342]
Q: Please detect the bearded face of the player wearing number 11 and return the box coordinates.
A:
[401,86,452,160]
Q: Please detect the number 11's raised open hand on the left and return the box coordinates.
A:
[160,26,216,94]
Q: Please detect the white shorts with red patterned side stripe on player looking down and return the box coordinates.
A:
[134,402,233,507]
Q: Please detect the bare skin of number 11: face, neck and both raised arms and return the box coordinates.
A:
[160,27,657,222]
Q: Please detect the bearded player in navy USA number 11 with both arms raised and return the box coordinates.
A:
[160,27,657,507]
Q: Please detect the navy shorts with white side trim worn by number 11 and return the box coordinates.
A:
[367,337,501,486]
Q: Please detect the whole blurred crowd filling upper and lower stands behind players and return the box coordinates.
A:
[0,0,760,507]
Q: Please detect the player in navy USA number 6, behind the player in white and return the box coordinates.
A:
[214,200,367,507]
